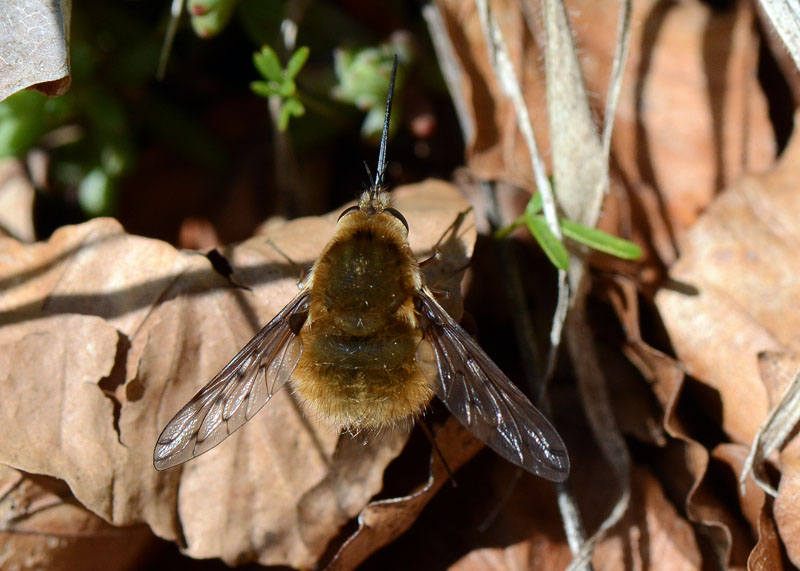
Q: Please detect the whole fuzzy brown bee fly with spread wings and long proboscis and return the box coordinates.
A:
[153,58,569,481]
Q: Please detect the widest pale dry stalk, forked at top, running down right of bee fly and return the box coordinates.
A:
[542,0,631,570]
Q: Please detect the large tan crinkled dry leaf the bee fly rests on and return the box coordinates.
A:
[0,181,475,567]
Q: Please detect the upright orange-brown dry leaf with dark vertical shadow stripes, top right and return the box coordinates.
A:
[608,1,776,241]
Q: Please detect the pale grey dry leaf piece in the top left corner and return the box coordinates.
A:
[0,0,72,101]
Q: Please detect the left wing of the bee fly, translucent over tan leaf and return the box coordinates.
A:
[153,290,309,470]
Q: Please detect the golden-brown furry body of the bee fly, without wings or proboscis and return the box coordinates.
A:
[292,206,433,430]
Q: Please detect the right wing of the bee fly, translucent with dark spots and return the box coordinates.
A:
[416,290,569,482]
